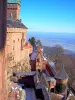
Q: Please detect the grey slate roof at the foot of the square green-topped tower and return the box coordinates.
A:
[7,19,28,29]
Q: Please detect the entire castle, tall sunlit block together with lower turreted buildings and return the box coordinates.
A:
[0,0,74,100]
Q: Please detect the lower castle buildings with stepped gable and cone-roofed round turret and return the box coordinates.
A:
[31,47,69,100]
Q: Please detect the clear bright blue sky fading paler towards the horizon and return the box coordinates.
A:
[20,0,75,33]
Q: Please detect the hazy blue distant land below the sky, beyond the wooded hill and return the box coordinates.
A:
[27,32,75,55]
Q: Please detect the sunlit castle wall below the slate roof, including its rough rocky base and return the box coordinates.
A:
[5,28,31,93]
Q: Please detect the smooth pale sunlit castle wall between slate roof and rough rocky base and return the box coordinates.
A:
[6,28,29,67]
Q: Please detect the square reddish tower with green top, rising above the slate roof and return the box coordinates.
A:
[7,0,21,20]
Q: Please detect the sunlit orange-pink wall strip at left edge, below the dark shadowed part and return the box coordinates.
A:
[0,50,7,100]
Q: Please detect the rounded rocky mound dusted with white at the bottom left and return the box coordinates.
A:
[8,82,26,100]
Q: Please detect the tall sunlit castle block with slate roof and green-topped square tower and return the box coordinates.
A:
[6,0,32,74]
